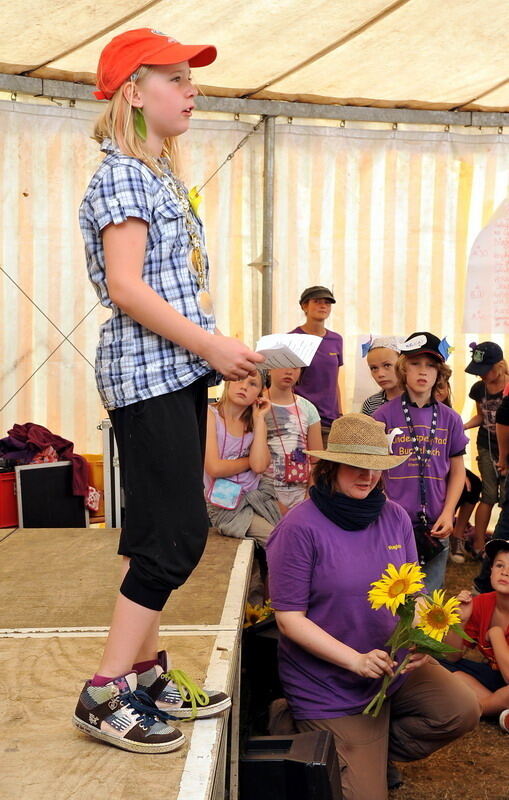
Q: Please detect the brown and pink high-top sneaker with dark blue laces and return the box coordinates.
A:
[73,672,185,753]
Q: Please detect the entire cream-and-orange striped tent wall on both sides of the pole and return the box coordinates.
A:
[0,97,509,452]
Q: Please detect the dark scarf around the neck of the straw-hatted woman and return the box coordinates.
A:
[309,481,386,531]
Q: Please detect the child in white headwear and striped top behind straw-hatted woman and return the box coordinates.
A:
[361,336,403,416]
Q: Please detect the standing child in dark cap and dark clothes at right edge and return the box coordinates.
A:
[465,342,509,559]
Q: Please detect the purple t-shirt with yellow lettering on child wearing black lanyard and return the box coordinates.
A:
[373,397,468,523]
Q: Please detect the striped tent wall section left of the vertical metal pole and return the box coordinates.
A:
[0,102,263,452]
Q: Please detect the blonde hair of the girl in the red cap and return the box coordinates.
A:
[92,65,179,175]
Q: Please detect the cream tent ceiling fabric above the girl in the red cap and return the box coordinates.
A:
[0,0,509,111]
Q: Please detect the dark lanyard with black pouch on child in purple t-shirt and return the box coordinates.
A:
[401,394,443,566]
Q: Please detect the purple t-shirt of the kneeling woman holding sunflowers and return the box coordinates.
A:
[267,500,417,719]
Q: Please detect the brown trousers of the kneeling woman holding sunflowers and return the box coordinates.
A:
[296,661,480,800]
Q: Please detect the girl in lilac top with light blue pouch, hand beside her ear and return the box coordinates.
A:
[204,372,280,547]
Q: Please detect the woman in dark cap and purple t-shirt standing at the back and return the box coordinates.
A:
[291,286,343,447]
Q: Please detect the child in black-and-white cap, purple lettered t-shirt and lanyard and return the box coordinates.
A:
[373,333,468,592]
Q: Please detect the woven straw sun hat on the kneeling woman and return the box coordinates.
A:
[304,414,408,470]
